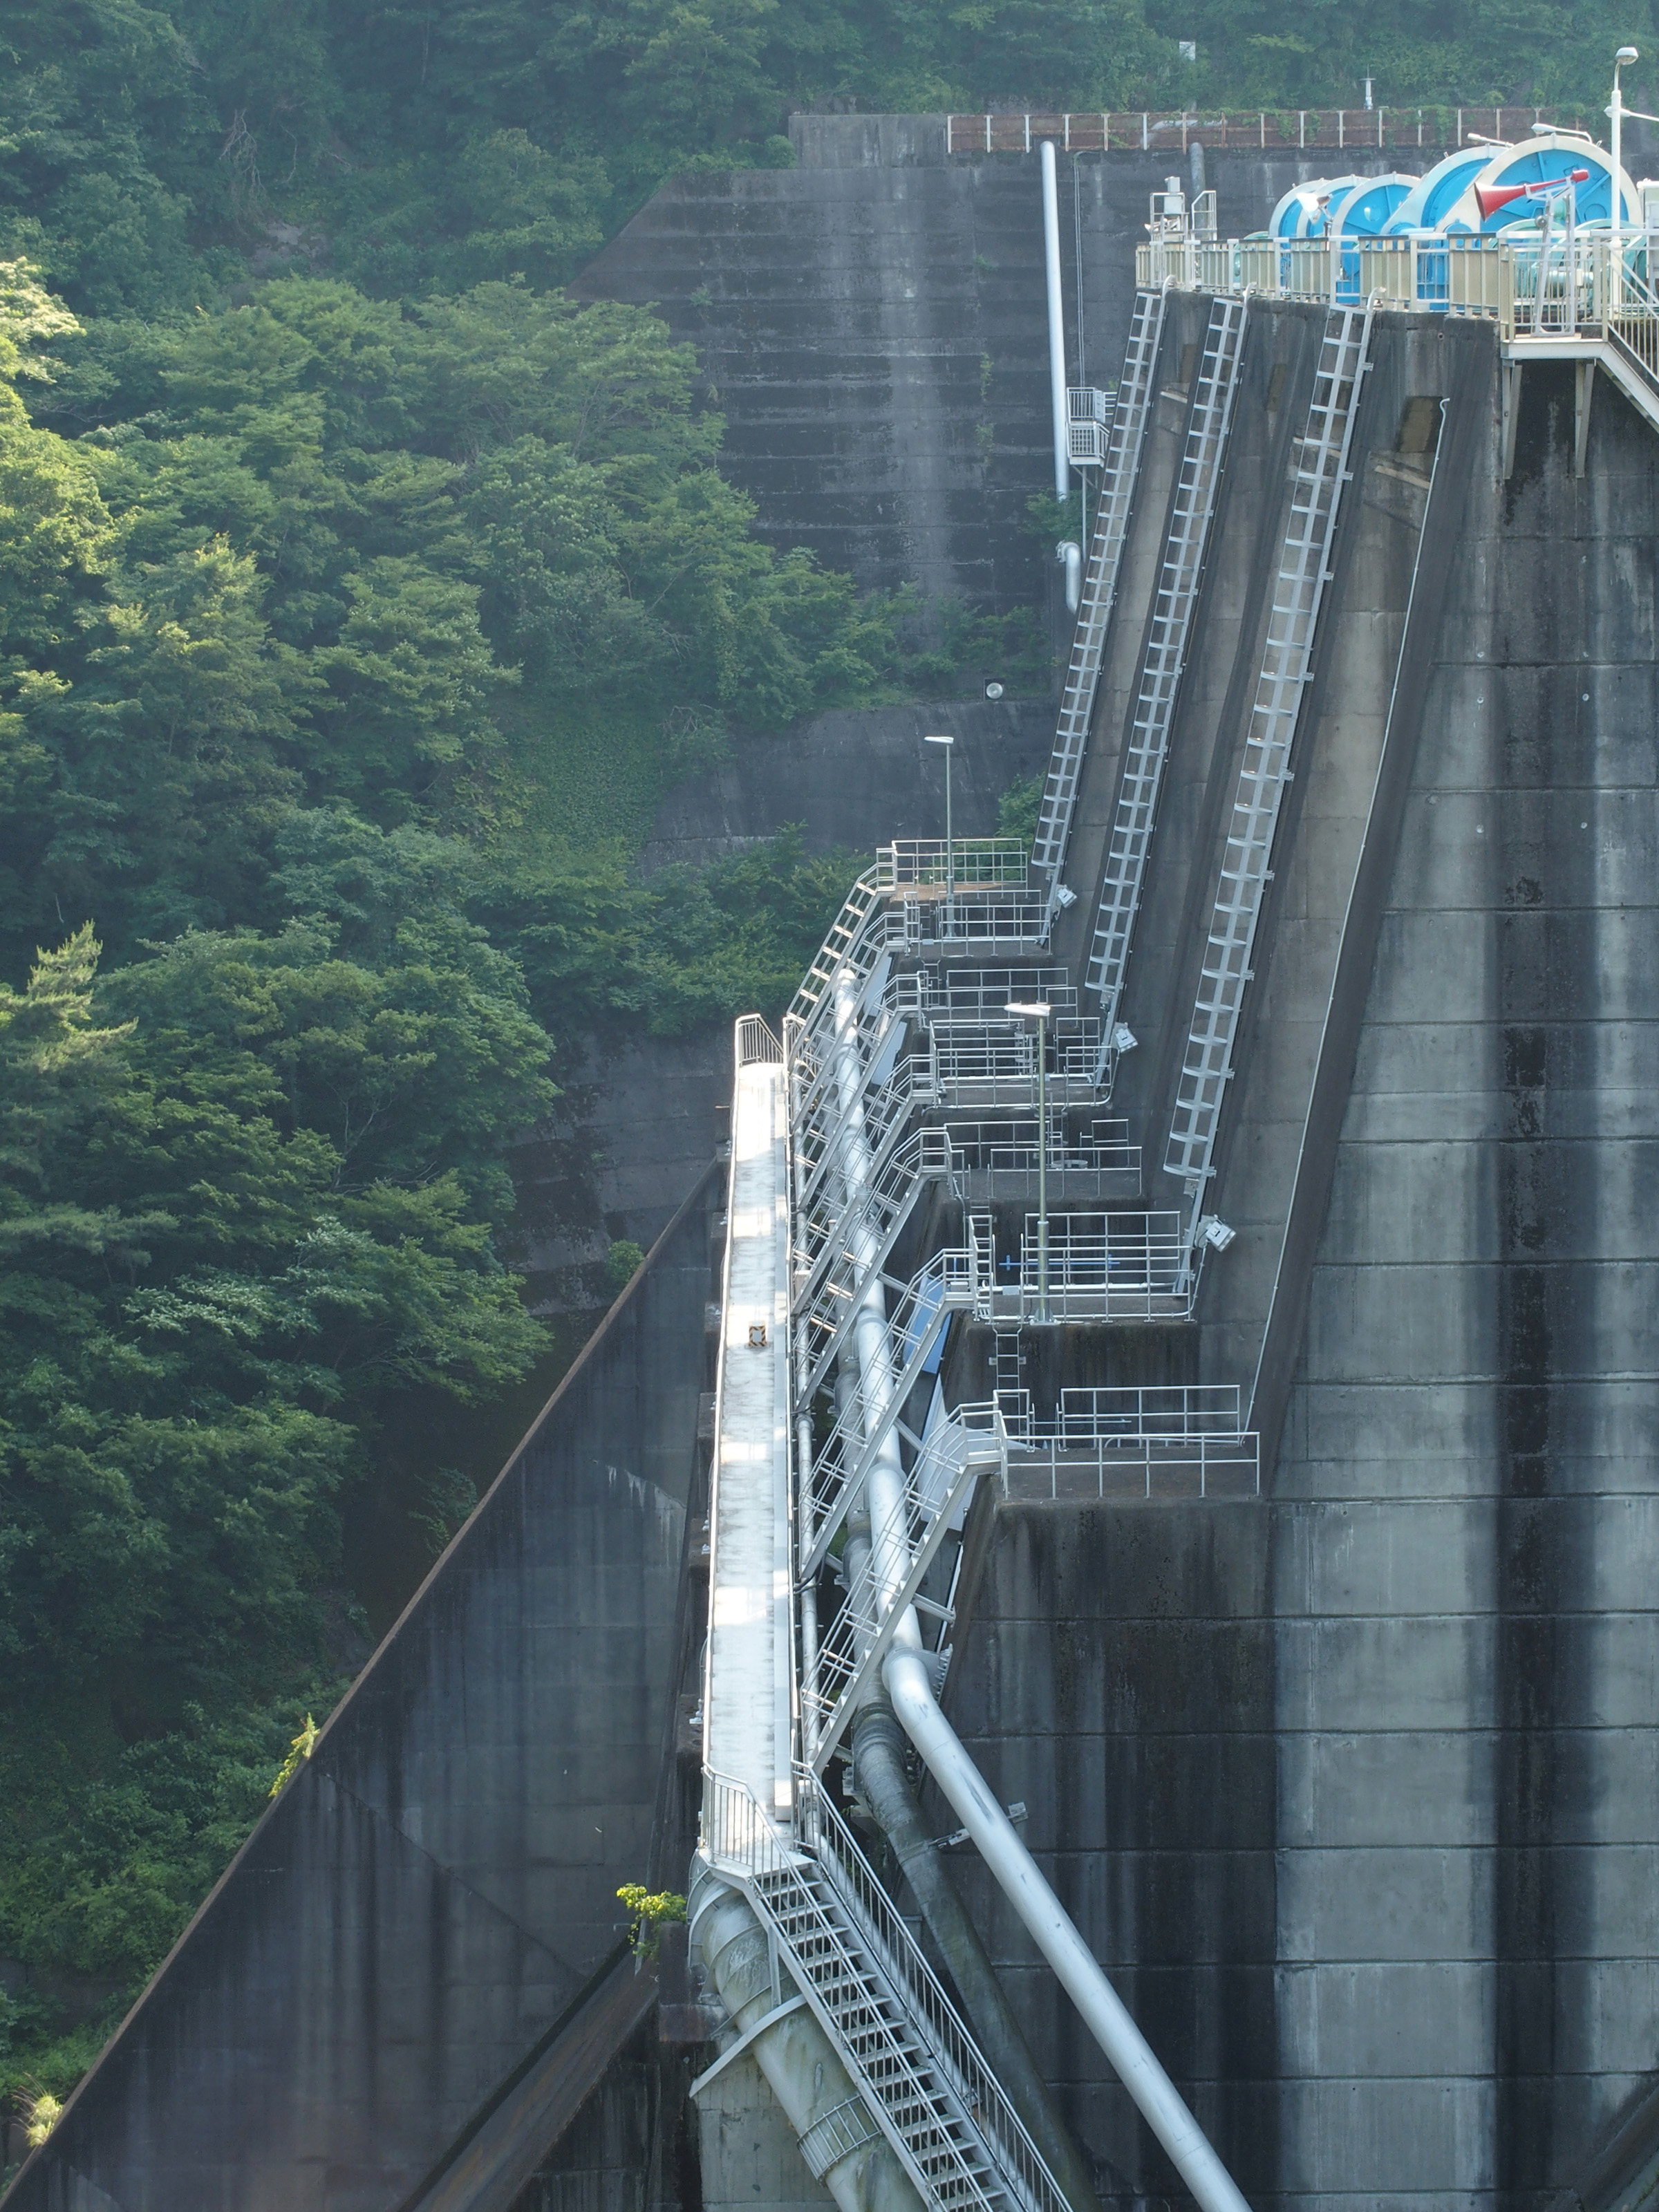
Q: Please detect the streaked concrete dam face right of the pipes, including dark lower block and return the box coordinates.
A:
[949,310,1659,2212]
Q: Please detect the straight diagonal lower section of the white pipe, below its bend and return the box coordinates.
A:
[883,1654,1250,2212]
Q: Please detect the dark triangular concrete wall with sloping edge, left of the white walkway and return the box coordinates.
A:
[7,1170,723,2212]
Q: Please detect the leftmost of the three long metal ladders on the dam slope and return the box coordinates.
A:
[1031,285,1168,920]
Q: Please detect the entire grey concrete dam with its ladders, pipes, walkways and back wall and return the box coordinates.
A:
[7,133,1659,2212]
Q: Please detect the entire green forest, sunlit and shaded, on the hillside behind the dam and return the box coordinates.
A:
[0,0,1652,2150]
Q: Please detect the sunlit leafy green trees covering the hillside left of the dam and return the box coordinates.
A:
[0,172,903,2103]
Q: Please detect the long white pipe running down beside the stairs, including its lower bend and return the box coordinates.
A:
[836,973,1250,2212]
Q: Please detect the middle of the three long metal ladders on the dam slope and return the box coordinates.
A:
[1084,299,1246,1073]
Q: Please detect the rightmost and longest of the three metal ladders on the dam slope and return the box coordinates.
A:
[1163,306,1371,1235]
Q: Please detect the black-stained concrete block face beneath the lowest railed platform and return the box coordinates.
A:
[936,1502,1279,2203]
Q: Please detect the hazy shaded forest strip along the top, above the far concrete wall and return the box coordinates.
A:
[0,0,1655,317]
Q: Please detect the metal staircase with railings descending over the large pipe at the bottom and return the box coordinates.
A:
[704,1772,1069,2212]
